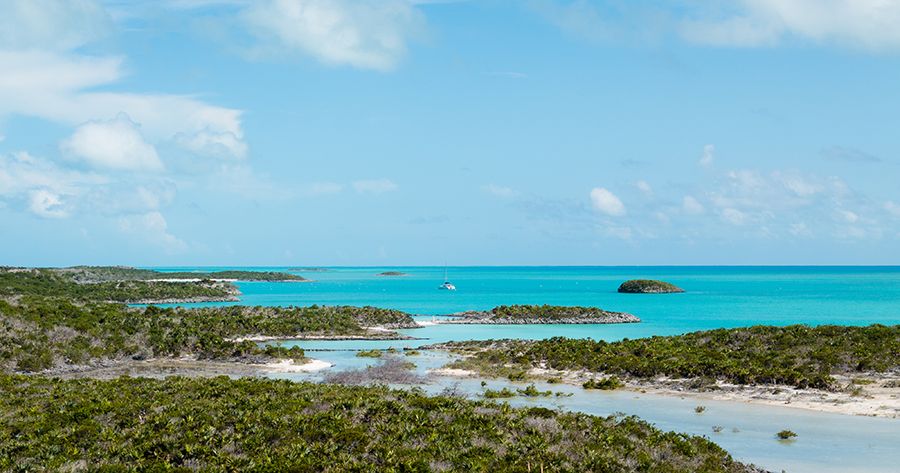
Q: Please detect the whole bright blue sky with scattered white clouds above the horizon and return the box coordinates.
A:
[0,0,900,266]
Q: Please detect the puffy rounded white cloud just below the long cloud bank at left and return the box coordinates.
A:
[60,114,163,171]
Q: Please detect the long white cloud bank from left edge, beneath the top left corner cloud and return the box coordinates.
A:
[0,50,246,157]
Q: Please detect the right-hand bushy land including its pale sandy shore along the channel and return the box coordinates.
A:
[432,325,900,417]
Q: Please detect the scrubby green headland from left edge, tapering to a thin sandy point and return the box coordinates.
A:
[0,296,415,372]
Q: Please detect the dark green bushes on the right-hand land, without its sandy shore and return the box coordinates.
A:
[450,325,900,389]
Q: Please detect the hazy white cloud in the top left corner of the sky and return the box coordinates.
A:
[0,0,112,50]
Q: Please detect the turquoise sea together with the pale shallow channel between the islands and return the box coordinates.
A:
[156,267,900,472]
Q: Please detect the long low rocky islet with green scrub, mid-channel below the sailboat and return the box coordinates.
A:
[442,305,641,325]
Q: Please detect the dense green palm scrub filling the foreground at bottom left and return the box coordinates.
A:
[0,375,761,473]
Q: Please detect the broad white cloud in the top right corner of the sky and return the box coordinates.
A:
[681,0,900,50]
